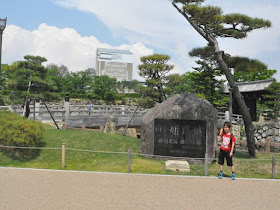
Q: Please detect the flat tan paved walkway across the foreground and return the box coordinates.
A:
[0,168,280,209]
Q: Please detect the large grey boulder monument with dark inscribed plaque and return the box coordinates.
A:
[140,94,218,160]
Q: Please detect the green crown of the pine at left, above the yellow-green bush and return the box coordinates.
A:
[5,55,63,104]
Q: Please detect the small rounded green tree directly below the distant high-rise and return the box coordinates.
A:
[92,75,117,103]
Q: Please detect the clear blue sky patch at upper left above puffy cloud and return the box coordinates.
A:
[0,0,125,44]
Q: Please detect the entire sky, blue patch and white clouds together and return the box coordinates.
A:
[0,0,280,81]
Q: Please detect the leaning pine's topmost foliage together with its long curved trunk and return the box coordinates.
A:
[172,0,271,157]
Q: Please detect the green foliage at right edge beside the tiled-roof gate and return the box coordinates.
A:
[263,81,280,120]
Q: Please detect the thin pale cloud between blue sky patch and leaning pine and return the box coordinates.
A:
[53,0,206,73]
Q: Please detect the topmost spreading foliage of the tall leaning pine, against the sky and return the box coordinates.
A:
[177,0,271,39]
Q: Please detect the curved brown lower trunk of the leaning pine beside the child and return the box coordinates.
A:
[214,43,256,157]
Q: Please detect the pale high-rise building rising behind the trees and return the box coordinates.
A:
[96,48,133,81]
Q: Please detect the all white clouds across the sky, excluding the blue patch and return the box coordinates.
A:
[2,0,280,80]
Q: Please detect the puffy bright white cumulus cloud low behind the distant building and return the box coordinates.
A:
[3,23,153,80]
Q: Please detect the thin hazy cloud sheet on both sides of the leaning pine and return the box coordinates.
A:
[54,0,280,78]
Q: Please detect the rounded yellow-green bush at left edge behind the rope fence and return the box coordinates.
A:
[0,112,45,147]
